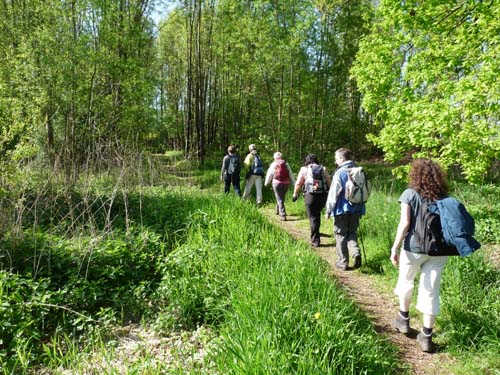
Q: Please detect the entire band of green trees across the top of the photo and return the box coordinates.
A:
[0,0,500,181]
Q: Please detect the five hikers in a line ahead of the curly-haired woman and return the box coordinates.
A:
[221,144,365,271]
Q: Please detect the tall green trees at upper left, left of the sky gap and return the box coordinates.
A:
[0,0,155,178]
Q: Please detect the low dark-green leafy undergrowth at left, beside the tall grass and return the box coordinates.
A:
[0,183,213,371]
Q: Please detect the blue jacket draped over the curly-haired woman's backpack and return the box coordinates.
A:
[429,197,481,256]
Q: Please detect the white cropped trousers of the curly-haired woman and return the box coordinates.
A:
[394,250,448,315]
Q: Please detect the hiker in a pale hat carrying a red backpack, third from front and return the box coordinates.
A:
[264,151,295,220]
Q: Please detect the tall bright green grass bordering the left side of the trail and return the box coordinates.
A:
[159,196,402,374]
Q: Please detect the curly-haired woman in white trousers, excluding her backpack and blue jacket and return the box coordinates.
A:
[391,159,448,352]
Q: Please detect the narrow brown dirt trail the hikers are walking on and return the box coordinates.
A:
[261,209,453,375]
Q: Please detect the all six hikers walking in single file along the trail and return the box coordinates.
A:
[221,144,479,352]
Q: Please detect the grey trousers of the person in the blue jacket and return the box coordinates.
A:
[333,212,361,266]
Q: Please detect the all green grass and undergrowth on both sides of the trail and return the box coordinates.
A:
[0,154,500,374]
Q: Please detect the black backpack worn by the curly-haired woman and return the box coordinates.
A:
[413,198,460,256]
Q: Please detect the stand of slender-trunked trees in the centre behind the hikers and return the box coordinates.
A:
[157,0,372,158]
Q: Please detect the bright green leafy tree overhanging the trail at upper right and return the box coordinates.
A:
[352,0,500,182]
